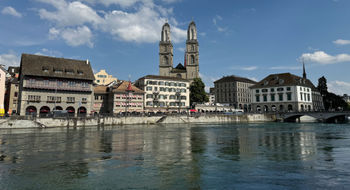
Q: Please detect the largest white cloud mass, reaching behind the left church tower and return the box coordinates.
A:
[37,0,187,47]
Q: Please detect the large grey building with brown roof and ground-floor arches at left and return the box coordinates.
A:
[18,54,94,116]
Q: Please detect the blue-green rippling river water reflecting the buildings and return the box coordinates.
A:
[0,123,350,190]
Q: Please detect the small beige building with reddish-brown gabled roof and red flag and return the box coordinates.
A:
[108,81,144,114]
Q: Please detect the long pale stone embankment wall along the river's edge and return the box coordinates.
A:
[0,114,276,128]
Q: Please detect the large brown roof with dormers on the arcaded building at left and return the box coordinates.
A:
[20,54,95,80]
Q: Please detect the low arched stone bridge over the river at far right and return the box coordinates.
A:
[276,111,350,123]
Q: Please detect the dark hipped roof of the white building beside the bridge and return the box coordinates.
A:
[251,73,316,90]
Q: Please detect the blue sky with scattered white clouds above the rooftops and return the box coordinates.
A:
[0,0,350,95]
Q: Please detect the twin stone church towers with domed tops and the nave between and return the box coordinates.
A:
[159,21,199,81]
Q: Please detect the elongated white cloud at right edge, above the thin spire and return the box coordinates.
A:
[299,51,350,65]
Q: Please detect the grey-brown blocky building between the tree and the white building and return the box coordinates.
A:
[214,75,257,112]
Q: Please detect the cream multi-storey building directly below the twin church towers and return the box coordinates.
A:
[135,75,190,112]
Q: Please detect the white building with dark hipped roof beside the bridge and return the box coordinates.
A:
[251,73,313,112]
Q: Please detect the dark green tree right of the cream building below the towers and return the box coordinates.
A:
[190,78,209,105]
